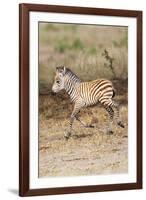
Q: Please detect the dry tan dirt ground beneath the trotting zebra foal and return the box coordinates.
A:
[39,83,128,177]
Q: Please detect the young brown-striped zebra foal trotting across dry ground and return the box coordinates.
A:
[52,66,124,138]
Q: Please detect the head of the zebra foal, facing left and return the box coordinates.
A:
[52,66,66,93]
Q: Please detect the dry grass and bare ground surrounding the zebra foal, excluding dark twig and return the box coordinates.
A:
[39,23,128,177]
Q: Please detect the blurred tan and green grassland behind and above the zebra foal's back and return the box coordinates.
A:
[39,22,128,94]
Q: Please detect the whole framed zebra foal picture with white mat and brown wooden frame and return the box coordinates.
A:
[19,4,142,196]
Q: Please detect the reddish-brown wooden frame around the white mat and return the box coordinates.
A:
[19,4,142,196]
